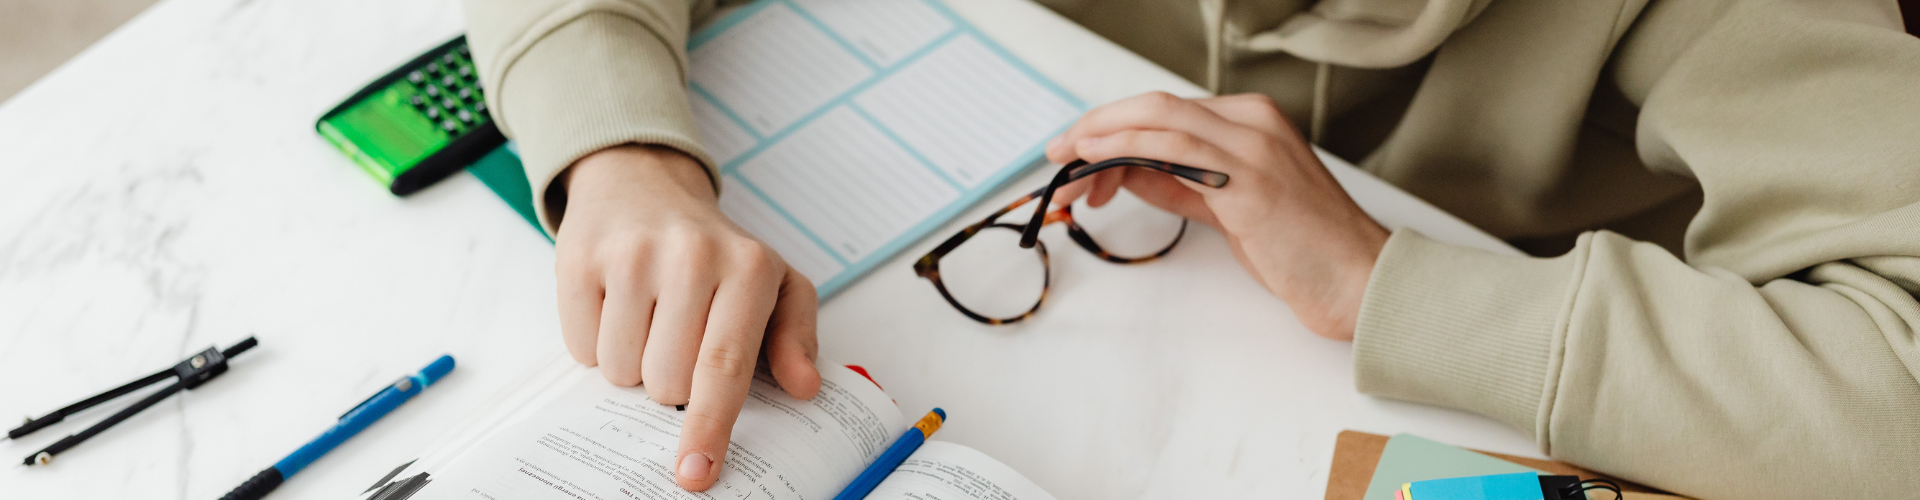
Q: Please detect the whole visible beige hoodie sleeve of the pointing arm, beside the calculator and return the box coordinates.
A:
[467,0,718,233]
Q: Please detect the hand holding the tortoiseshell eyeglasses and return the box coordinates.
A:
[1046,92,1388,340]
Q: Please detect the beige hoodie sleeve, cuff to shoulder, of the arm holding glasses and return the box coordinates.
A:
[1356,0,1920,498]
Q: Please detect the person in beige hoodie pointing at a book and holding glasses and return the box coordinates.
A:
[467,0,1920,498]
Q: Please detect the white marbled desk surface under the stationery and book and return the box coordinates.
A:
[0,0,1538,500]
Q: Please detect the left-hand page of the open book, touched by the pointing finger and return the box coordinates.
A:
[413,365,906,500]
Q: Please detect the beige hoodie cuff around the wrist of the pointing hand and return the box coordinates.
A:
[499,13,720,233]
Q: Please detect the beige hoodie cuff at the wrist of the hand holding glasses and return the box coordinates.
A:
[1354,229,1590,442]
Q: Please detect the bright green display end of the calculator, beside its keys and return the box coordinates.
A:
[319,81,453,183]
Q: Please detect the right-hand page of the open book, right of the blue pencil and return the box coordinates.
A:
[866,440,1054,500]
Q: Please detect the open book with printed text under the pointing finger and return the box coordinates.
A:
[369,356,1052,500]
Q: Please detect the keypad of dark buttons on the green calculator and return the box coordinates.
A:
[403,44,492,138]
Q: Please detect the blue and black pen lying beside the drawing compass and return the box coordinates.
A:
[221,356,453,500]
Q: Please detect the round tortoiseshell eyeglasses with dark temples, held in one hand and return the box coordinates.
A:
[914,158,1227,325]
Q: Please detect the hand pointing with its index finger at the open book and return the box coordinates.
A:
[555,146,820,490]
